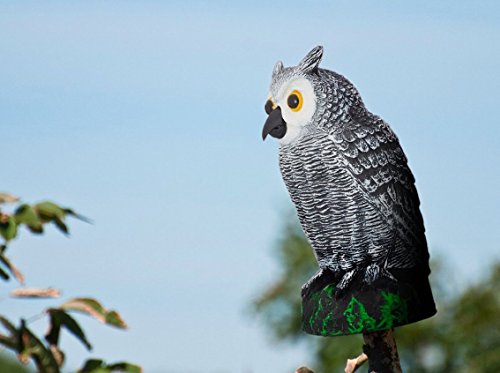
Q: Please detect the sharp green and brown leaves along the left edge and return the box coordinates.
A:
[0,193,141,373]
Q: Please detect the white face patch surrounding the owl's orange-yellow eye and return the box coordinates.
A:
[274,77,316,144]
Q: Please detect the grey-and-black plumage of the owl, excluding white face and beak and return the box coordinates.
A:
[266,47,429,289]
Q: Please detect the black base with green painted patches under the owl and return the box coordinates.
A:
[302,270,436,337]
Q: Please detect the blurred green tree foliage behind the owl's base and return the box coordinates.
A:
[252,214,500,373]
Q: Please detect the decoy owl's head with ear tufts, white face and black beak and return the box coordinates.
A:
[262,46,364,144]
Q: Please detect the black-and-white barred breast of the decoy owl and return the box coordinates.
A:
[280,133,394,271]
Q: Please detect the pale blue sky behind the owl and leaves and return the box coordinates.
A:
[0,1,500,373]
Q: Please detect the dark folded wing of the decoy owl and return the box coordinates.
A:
[329,113,429,268]
